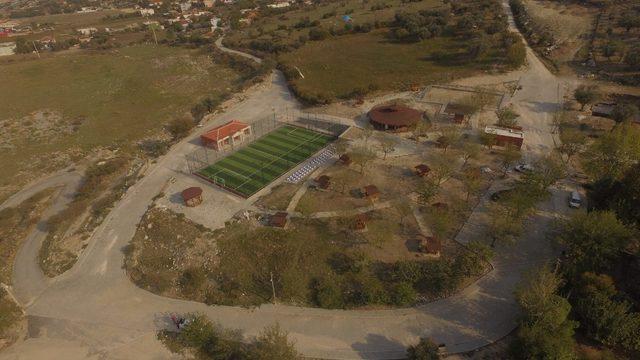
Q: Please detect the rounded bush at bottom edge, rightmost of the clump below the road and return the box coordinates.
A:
[249,324,298,360]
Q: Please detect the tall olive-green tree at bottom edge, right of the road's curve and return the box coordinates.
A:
[511,267,576,360]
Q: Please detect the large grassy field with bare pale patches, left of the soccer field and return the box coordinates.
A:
[0,45,240,198]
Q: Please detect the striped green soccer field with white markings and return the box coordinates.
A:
[197,125,334,197]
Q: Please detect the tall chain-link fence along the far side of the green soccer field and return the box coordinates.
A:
[186,110,349,173]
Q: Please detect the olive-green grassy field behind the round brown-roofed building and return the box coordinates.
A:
[280,31,510,98]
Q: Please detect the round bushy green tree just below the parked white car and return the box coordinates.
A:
[556,211,633,279]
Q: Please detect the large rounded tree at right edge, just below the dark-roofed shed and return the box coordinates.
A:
[583,123,640,180]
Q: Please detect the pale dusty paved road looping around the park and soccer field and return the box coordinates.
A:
[0,3,566,359]
